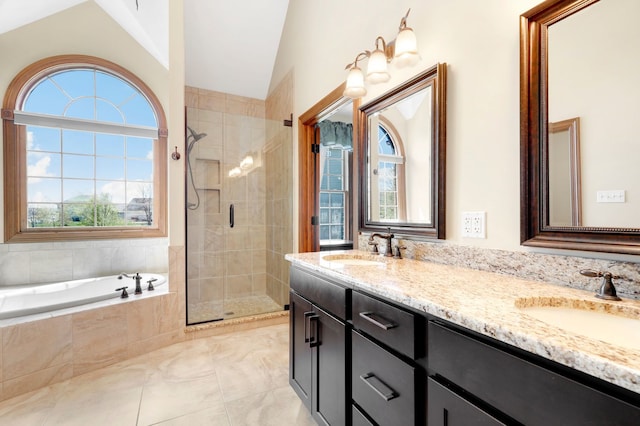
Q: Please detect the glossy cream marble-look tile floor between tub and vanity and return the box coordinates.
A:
[0,324,315,426]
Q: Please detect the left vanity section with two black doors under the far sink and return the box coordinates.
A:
[289,268,350,425]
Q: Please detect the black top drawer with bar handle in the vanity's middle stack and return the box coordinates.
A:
[351,291,424,359]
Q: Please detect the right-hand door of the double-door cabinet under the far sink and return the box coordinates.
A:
[310,306,348,426]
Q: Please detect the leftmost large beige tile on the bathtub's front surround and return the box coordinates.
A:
[2,315,73,382]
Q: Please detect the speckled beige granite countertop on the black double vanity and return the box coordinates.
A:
[286,251,640,393]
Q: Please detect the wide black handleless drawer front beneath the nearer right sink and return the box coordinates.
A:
[428,322,640,426]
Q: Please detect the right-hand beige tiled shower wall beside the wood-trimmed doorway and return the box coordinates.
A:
[265,72,294,306]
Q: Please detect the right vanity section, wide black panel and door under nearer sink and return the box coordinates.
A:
[428,321,640,426]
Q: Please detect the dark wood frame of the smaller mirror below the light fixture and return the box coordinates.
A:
[356,63,447,239]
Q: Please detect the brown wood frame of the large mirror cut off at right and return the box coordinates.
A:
[520,0,640,255]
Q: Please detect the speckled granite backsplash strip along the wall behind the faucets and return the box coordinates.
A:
[358,234,640,300]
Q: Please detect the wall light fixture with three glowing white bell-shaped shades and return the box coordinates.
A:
[343,9,420,99]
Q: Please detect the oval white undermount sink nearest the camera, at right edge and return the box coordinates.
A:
[516,297,640,350]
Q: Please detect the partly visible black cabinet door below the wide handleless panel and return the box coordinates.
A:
[427,378,504,426]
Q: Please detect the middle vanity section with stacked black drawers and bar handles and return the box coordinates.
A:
[351,291,426,425]
